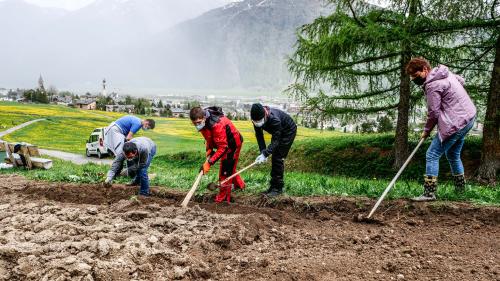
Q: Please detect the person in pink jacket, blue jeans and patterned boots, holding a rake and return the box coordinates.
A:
[406,58,476,201]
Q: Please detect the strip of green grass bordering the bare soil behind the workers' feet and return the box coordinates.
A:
[0,156,500,205]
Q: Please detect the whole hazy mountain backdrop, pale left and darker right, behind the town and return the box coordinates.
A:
[0,0,333,93]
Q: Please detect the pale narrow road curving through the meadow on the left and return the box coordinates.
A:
[0,119,113,165]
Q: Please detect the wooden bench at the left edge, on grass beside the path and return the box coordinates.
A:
[0,141,52,170]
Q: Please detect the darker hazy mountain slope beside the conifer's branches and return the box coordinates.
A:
[138,0,333,91]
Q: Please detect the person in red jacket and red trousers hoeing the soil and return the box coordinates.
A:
[189,106,245,203]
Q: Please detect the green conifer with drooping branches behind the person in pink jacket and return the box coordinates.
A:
[287,0,498,167]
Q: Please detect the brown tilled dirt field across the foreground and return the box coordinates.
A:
[0,176,500,280]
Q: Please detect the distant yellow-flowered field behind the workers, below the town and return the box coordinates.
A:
[0,102,339,155]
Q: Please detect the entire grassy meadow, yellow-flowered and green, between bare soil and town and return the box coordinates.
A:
[0,100,500,205]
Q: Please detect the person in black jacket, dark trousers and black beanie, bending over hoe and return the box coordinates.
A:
[250,103,297,197]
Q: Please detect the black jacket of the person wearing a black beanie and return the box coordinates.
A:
[254,106,297,157]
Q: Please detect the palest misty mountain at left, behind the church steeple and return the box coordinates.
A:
[0,0,231,90]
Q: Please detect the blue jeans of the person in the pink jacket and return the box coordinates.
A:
[425,117,476,177]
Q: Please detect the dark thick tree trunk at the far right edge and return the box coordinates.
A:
[478,36,500,184]
